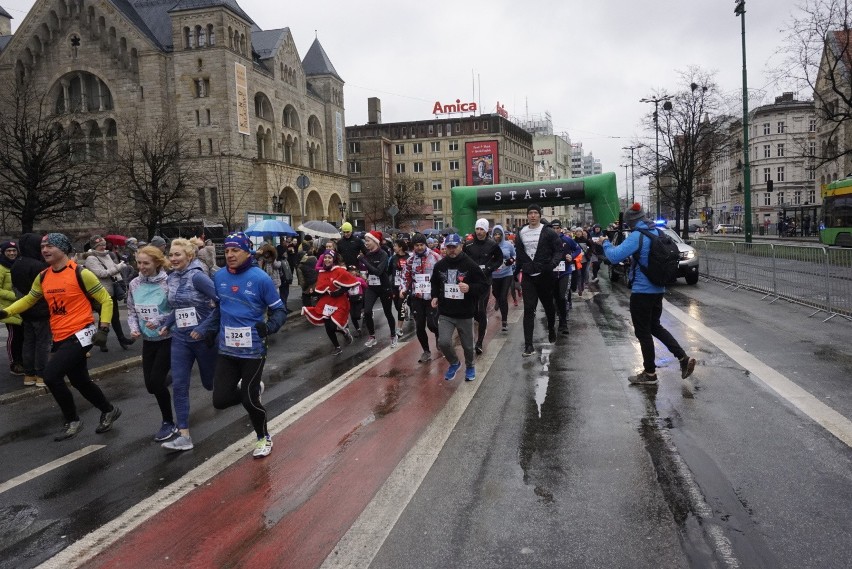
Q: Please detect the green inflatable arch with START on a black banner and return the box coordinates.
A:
[450,172,620,235]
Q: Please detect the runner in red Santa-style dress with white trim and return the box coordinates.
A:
[302,251,361,356]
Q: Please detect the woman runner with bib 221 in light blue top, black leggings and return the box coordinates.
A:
[127,245,178,442]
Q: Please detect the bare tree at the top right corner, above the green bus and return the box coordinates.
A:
[775,0,852,167]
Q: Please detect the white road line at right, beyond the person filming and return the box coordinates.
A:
[665,301,852,446]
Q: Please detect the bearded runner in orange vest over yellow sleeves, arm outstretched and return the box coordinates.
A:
[0,233,121,441]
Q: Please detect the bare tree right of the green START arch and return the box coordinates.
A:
[640,67,730,236]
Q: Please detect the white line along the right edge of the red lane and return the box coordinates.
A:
[320,310,521,569]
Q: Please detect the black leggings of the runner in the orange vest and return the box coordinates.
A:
[44,336,112,423]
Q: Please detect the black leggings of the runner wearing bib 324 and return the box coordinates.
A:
[213,354,269,439]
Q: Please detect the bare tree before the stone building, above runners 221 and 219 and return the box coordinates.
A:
[114,117,201,240]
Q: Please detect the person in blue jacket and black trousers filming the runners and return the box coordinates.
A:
[602,203,695,385]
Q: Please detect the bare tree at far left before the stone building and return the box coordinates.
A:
[0,77,106,233]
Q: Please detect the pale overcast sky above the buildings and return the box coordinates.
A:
[5,0,812,200]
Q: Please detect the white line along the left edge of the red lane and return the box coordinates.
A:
[39,343,408,569]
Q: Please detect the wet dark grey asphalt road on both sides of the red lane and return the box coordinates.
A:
[0,279,852,568]
